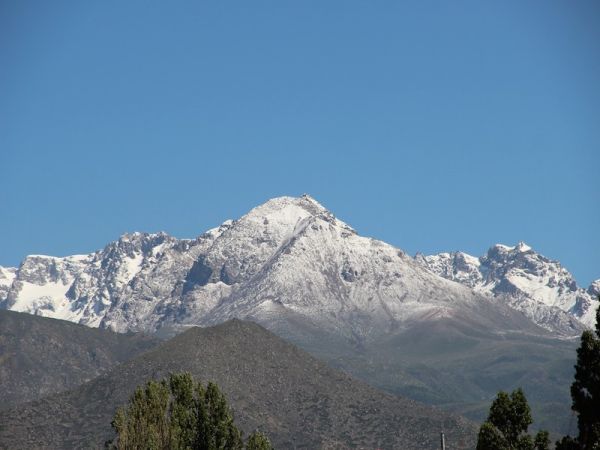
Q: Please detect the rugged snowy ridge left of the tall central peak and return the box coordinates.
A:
[0,233,216,327]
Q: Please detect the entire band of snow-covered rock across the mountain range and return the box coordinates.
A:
[0,195,589,343]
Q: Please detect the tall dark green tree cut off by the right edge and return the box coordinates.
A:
[556,297,600,450]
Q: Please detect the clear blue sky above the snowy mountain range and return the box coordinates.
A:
[0,0,600,285]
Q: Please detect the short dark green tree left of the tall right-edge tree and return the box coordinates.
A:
[477,388,550,450]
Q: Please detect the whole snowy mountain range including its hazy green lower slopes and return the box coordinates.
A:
[0,195,597,430]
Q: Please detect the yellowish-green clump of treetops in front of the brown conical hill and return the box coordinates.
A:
[109,373,272,450]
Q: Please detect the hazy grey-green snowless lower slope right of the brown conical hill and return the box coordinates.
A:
[238,302,579,434]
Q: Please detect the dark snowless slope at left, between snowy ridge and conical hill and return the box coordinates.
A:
[0,310,159,409]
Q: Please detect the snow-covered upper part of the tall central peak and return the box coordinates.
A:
[103,196,492,339]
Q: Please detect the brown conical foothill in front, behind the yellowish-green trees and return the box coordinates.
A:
[0,320,476,449]
